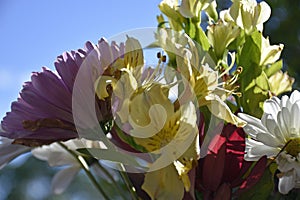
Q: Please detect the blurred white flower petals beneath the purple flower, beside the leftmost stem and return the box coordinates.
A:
[31,139,105,194]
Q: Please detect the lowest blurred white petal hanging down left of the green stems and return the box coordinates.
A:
[52,166,80,194]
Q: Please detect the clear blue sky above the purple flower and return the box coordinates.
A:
[0,0,160,118]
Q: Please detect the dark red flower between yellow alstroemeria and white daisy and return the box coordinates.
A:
[196,124,267,199]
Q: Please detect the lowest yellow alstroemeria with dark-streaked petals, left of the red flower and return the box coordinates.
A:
[131,103,199,199]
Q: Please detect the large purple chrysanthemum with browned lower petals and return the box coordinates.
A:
[0,39,124,146]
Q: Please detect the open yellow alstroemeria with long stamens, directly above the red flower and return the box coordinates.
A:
[176,35,245,126]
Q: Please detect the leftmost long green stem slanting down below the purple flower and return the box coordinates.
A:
[58,142,109,200]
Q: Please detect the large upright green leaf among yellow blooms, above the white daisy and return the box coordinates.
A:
[237,32,269,118]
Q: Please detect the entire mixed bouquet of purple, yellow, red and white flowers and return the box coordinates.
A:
[0,0,300,199]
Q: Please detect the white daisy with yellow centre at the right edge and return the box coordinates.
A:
[239,90,300,194]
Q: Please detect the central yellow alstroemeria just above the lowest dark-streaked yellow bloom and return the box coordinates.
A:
[113,57,171,125]
